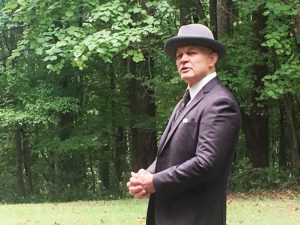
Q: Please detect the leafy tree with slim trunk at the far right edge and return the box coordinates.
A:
[264,0,300,168]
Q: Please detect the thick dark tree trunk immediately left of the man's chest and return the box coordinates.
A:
[127,57,157,171]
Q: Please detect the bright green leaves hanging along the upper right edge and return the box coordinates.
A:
[263,1,300,99]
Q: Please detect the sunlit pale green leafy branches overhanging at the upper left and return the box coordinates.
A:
[4,0,170,73]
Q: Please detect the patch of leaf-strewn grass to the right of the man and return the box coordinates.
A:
[227,194,300,225]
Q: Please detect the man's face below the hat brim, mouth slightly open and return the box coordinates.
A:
[176,45,218,87]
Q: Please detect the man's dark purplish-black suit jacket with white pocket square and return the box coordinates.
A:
[147,78,241,225]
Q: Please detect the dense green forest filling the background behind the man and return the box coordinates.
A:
[0,0,300,202]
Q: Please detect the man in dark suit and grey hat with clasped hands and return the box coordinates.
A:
[127,24,241,225]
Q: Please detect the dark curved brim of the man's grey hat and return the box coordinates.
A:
[164,36,226,59]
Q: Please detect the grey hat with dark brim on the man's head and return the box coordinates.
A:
[165,24,226,59]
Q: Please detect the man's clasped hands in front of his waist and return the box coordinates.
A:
[127,169,155,198]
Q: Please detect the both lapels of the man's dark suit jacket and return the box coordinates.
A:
[157,78,219,155]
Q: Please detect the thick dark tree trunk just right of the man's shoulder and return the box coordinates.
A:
[242,5,269,167]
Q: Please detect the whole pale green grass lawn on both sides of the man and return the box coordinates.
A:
[0,194,300,225]
